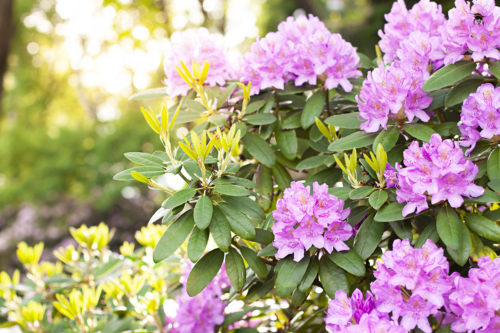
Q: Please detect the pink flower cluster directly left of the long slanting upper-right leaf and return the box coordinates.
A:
[356,58,432,133]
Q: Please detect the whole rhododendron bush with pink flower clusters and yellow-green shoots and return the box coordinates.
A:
[0,0,500,333]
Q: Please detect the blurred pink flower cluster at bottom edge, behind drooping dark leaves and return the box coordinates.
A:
[165,262,230,333]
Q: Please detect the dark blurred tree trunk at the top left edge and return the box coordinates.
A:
[0,0,14,118]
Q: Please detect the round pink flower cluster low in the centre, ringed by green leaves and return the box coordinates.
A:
[273,182,353,261]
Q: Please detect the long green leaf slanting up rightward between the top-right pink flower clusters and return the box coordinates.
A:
[423,60,476,92]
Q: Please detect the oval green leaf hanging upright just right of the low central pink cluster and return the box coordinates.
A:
[354,214,384,260]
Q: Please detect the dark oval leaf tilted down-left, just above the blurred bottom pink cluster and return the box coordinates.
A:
[186,249,224,297]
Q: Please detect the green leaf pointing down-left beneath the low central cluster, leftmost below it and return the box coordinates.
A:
[276,251,309,298]
